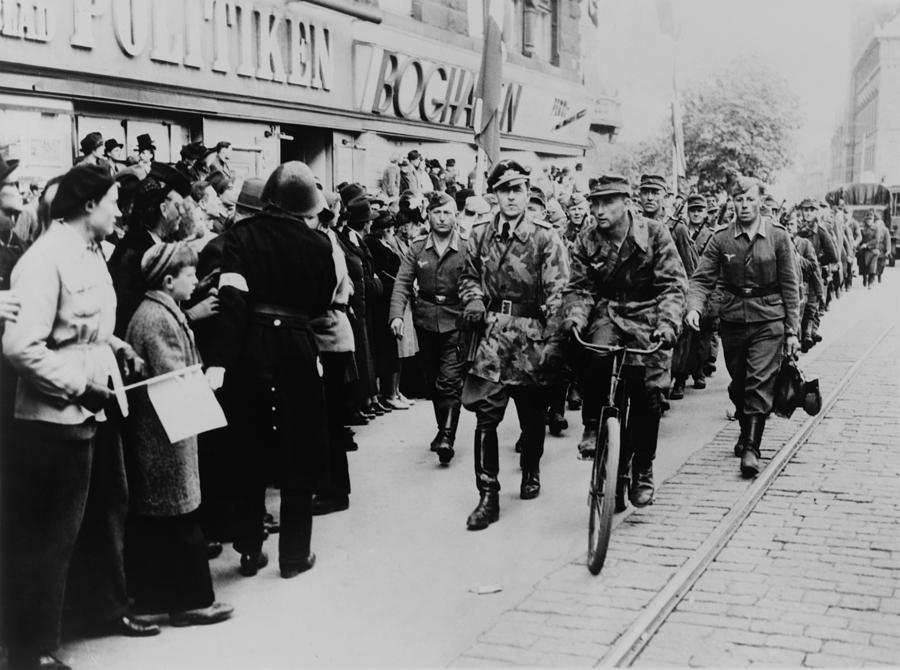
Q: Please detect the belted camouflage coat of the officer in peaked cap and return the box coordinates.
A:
[459,212,569,386]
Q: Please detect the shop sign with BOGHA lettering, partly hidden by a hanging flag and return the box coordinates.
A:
[360,48,522,133]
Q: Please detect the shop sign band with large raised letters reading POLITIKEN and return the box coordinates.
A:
[0,0,349,106]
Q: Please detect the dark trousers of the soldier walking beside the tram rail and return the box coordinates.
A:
[719,321,784,416]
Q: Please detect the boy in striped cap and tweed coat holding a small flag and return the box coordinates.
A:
[124,242,233,626]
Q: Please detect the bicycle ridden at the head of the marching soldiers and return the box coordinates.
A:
[573,331,661,575]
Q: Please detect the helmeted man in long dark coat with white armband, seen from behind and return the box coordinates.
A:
[207,161,336,578]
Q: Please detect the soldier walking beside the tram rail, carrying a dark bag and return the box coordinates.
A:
[686,178,800,477]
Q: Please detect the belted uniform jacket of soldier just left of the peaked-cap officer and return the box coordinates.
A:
[388,229,469,333]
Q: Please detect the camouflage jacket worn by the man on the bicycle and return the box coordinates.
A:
[563,212,687,360]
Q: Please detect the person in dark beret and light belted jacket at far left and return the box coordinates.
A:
[2,166,159,669]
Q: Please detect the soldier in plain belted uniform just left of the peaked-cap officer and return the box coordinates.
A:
[389,191,468,465]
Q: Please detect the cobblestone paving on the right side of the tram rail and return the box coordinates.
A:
[637,328,900,667]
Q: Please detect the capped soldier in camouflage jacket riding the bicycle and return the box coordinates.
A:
[562,175,687,510]
